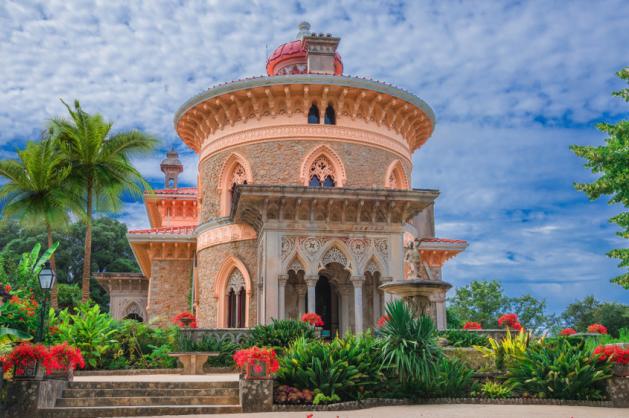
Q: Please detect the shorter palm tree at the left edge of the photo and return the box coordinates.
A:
[0,139,80,307]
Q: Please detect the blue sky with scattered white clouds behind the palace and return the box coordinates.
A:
[0,0,629,311]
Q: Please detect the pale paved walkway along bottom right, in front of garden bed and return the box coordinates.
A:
[163,405,629,418]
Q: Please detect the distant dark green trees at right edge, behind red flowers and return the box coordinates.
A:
[562,296,629,336]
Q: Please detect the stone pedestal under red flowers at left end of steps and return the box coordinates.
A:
[5,380,68,418]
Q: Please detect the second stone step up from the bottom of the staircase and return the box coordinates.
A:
[55,396,240,408]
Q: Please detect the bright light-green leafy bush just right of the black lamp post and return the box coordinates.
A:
[49,304,119,369]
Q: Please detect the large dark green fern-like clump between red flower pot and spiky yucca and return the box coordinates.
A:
[277,334,384,402]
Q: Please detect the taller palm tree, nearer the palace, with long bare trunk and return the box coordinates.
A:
[50,100,157,302]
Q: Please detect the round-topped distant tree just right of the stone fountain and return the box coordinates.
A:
[448,280,549,330]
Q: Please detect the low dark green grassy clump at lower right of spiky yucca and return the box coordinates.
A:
[419,357,474,398]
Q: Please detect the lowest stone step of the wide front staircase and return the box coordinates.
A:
[40,405,242,418]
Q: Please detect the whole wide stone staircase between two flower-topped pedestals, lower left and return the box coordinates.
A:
[40,381,242,418]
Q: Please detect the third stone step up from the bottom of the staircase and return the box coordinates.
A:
[62,387,239,398]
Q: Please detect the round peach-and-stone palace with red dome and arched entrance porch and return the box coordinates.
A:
[97,22,467,334]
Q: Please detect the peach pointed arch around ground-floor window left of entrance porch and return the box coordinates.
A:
[214,256,253,328]
